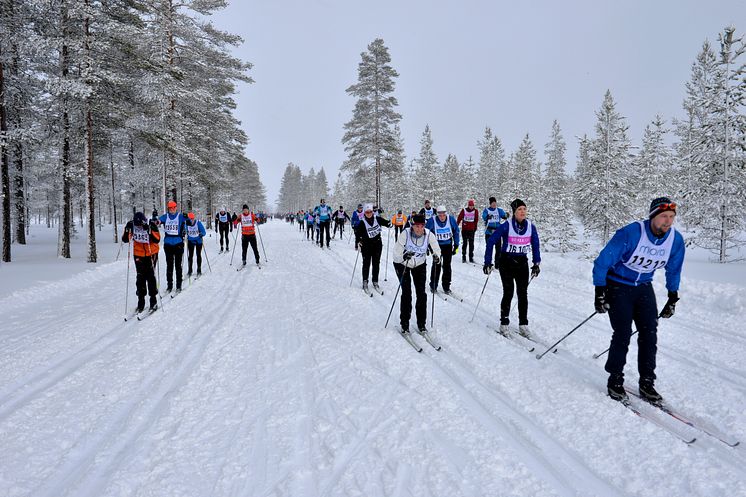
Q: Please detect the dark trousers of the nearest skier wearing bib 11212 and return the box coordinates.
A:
[604,281,658,380]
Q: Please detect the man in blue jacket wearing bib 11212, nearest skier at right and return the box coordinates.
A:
[593,197,685,404]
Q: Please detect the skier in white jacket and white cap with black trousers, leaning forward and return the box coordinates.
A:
[393,214,440,334]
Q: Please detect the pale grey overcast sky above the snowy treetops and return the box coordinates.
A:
[212,0,746,204]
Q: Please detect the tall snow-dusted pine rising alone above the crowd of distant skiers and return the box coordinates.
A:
[342,38,401,205]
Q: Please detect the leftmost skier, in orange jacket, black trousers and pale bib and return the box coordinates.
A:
[122,212,161,314]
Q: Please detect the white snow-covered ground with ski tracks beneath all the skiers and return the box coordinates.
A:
[0,221,746,497]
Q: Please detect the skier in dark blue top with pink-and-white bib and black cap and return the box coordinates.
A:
[484,198,541,338]
